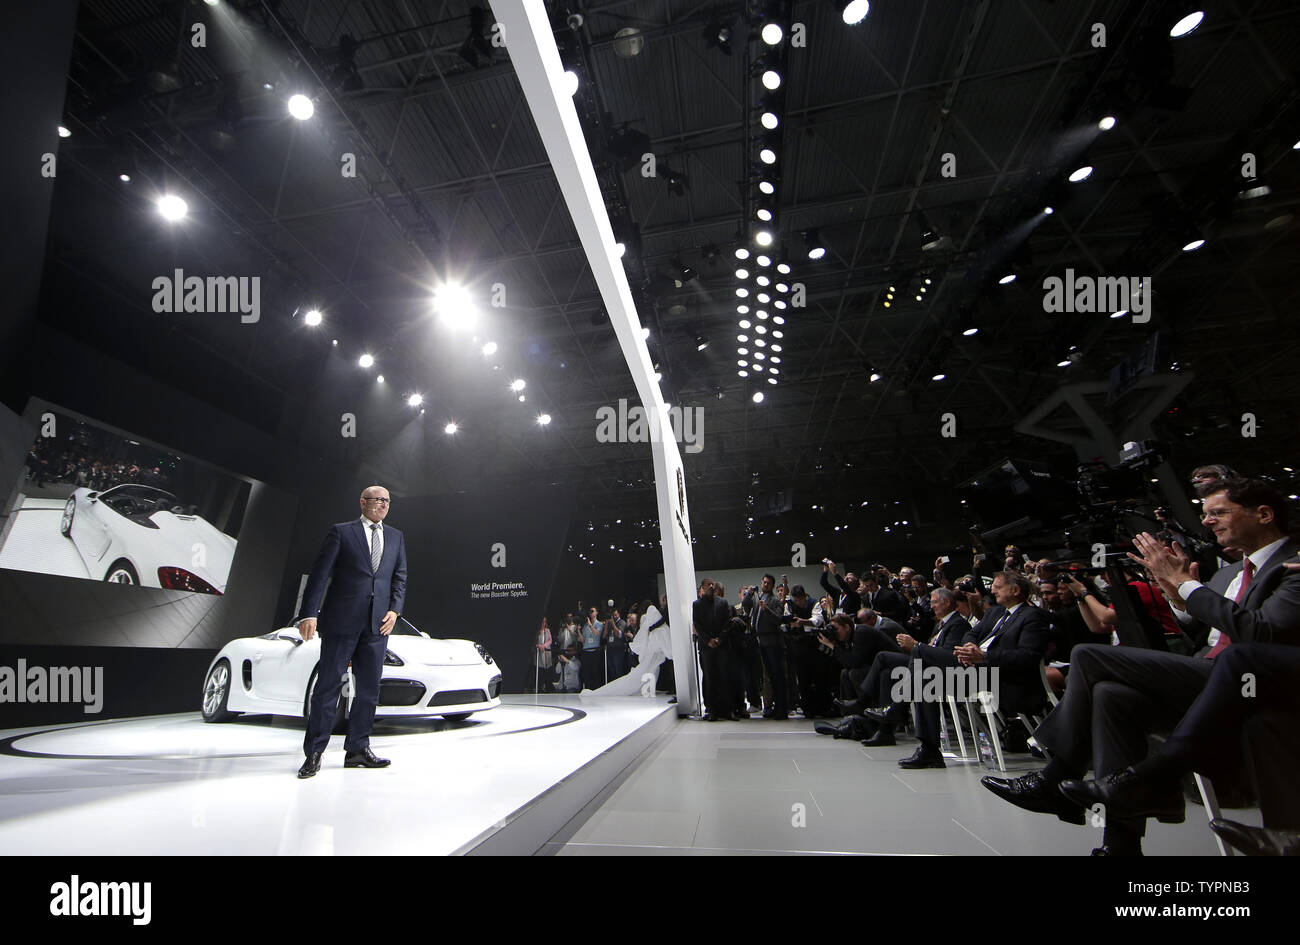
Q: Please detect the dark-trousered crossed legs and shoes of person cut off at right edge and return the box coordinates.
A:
[1061,643,1300,857]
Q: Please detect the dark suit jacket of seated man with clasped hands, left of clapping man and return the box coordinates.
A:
[913,603,1052,712]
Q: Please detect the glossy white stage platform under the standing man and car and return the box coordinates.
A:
[0,695,676,855]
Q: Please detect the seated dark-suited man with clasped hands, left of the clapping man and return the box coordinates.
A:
[863,571,1050,768]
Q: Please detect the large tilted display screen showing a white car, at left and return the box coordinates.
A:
[0,407,251,594]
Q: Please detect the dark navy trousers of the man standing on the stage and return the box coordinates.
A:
[303,629,389,755]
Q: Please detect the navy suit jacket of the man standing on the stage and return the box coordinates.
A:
[294,519,406,636]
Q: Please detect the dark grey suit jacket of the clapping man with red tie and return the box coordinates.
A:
[1183,538,1300,645]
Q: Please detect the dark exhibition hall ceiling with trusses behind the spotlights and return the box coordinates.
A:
[43,0,1300,569]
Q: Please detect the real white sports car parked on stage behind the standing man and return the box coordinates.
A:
[203,617,501,728]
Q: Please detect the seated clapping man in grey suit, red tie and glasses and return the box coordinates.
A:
[982,478,1300,855]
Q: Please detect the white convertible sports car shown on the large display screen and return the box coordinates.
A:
[59,484,235,594]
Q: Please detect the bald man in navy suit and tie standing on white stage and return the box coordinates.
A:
[295,486,406,777]
